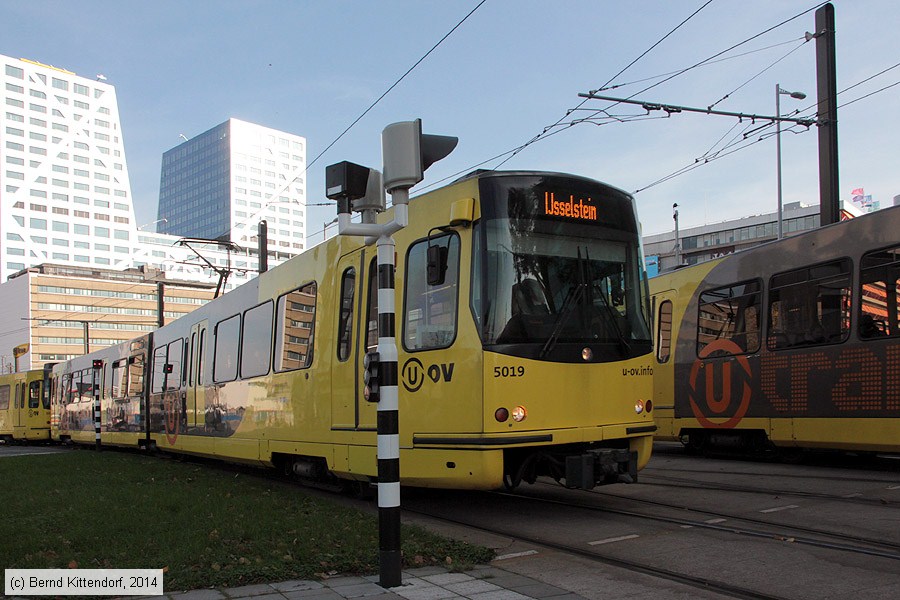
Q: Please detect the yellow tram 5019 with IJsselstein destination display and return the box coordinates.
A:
[52,172,656,489]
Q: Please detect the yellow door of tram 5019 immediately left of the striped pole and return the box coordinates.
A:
[331,248,378,431]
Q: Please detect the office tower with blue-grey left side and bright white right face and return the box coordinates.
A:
[157,119,306,259]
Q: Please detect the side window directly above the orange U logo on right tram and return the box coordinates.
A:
[697,280,762,355]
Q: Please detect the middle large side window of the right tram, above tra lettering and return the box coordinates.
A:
[766,259,851,350]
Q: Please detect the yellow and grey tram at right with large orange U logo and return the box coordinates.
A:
[650,208,900,452]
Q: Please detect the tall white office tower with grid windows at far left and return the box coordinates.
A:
[0,55,136,281]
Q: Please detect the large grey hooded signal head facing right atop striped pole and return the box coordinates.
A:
[381,119,459,192]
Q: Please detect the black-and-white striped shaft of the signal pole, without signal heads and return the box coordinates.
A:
[376,235,402,588]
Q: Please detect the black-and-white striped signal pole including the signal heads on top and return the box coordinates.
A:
[325,119,457,588]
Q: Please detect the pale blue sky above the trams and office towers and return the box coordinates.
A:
[0,0,900,241]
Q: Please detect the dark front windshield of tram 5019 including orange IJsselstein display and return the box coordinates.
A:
[473,173,650,362]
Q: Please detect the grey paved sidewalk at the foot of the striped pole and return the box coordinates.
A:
[145,566,582,600]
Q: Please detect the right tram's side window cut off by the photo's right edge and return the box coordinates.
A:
[859,247,900,339]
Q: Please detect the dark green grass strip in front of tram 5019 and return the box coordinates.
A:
[0,450,493,591]
